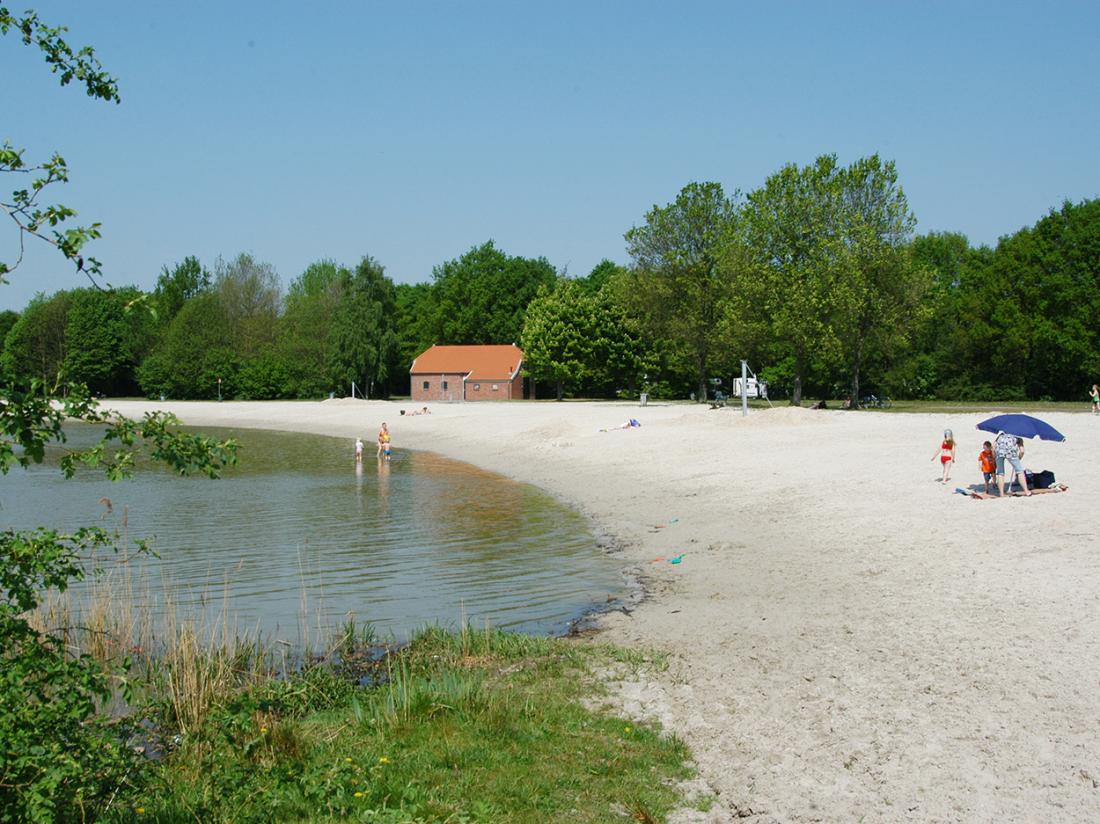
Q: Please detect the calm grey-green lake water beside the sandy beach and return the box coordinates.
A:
[0,427,624,645]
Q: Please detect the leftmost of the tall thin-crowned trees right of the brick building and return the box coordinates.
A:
[626,183,737,400]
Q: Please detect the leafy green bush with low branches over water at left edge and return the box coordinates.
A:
[0,383,235,822]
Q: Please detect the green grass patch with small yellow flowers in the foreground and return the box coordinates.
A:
[118,628,690,824]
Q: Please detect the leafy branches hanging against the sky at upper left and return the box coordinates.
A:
[0,6,120,283]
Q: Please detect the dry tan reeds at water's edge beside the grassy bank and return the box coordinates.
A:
[28,543,376,735]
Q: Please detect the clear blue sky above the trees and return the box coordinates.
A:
[0,0,1100,309]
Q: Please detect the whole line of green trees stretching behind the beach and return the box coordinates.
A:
[0,165,1100,403]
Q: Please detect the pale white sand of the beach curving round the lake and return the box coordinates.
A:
[108,400,1100,822]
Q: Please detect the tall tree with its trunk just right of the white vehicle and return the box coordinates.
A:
[746,155,847,406]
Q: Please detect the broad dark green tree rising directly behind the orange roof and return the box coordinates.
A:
[426,241,557,344]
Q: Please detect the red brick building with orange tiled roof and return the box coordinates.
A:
[409,343,525,400]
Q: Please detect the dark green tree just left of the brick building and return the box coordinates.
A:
[331,257,397,397]
